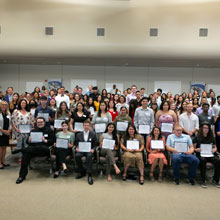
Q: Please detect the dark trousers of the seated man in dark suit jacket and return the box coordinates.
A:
[76,152,93,174]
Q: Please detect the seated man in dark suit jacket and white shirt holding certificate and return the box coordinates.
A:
[76,120,97,185]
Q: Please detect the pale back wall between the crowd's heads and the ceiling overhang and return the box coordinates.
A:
[0,64,220,93]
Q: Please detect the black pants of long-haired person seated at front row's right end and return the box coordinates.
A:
[199,156,220,183]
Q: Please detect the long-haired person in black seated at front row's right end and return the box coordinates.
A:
[193,122,220,188]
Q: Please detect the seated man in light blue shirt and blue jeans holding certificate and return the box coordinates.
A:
[166,125,199,185]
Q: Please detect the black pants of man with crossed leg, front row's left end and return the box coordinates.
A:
[19,146,50,179]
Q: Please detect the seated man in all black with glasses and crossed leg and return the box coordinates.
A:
[12,117,55,184]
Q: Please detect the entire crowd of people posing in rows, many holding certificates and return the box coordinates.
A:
[0,85,220,188]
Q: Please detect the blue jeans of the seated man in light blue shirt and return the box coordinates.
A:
[172,154,199,179]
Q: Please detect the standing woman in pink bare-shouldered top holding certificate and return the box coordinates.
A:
[155,101,177,137]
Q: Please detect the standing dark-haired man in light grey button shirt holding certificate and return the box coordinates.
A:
[134,97,154,141]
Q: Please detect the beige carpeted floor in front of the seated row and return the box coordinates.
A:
[0,148,220,220]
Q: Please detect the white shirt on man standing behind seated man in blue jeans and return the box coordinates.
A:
[179,112,199,131]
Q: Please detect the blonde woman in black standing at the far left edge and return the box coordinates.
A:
[0,101,11,169]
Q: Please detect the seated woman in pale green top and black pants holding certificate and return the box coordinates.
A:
[54,121,75,178]
